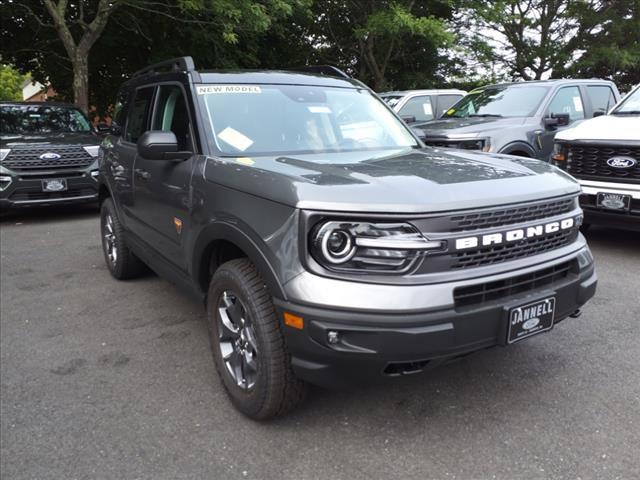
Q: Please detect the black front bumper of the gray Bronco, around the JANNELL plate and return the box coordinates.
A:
[276,247,597,388]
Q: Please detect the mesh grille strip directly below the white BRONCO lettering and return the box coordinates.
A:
[451,228,578,269]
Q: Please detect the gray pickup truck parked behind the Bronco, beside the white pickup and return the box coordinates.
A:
[412,80,620,161]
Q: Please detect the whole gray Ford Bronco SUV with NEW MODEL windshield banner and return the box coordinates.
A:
[99,57,596,419]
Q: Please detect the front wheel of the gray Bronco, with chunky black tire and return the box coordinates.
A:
[207,258,307,420]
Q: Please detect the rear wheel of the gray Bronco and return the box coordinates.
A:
[100,198,146,280]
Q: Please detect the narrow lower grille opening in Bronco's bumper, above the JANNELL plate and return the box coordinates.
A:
[453,260,577,308]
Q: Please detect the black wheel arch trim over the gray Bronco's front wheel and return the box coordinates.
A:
[191,221,287,300]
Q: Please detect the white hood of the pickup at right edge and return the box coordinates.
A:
[556,115,640,142]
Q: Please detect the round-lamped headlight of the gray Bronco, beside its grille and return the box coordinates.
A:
[309,221,445,273]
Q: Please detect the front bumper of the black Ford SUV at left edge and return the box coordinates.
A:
[0,166,98,211]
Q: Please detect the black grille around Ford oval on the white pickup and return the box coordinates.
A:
[567,144,640,183]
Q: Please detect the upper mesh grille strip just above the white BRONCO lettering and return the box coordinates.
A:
[451,197,576,232]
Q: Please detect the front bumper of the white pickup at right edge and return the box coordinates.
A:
[579,180,640,231]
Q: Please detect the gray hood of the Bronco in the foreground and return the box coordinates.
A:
[203,148,580,213]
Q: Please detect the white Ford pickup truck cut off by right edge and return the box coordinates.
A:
[551,85,640,231]
